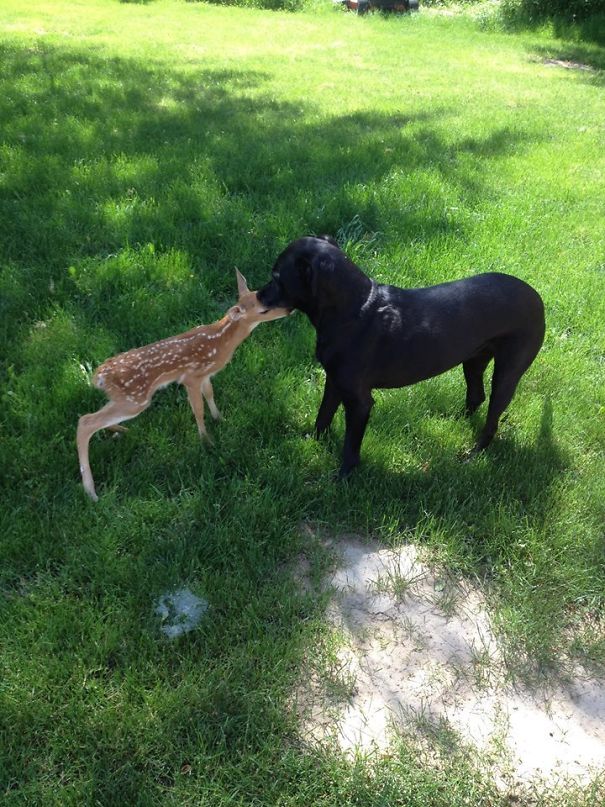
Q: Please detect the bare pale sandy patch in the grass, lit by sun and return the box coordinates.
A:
[297,538,605,786]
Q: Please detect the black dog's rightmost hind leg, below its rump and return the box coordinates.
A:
[473,335,542,453]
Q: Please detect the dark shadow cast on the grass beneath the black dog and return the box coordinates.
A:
[314,397,569,563]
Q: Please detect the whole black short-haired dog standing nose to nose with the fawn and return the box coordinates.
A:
[258,236,544,477]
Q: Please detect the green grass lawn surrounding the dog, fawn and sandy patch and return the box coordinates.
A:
[0,0,605,807]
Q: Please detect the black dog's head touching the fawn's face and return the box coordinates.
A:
[257,236,370,321]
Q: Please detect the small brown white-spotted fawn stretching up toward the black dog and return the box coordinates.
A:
[77,269,290,502]
